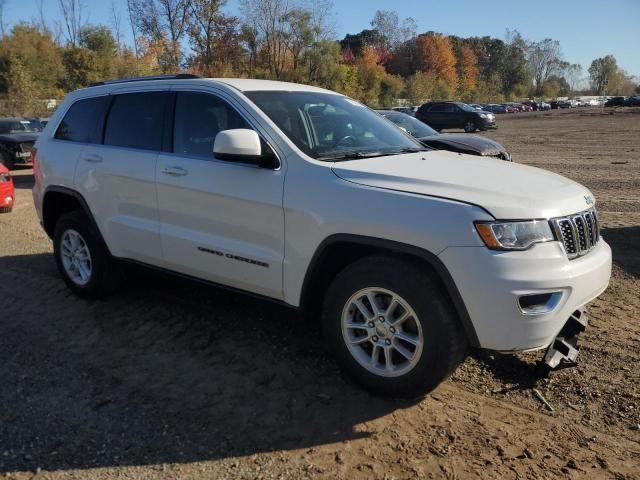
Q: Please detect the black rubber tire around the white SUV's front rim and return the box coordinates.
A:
[322,256,467,398]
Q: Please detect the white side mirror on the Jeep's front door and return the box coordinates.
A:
[213,128,279,169]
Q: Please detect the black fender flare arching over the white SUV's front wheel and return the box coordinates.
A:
[300,233,480,347]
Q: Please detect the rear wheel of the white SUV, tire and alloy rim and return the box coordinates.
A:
[53,211,117,298]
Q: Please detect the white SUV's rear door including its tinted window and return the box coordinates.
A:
[76,87,168,265]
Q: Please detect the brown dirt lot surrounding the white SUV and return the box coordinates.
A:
[0,109,640,479]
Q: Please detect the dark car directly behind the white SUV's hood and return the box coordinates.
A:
[378,110,511,162]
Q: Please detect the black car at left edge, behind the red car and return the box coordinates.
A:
[0,118,39,170]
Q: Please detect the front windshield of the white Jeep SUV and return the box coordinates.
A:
[246,91,424,160]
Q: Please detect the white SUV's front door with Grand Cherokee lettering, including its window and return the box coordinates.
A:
[156,87,284,298]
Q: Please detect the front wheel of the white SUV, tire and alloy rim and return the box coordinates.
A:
[323,256,466,397]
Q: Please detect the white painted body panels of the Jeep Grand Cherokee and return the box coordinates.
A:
[34,79,611,350]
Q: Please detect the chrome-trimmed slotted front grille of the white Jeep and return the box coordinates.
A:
[551,209,600,259]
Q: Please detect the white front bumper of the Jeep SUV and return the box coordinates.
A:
[439,239,611,351]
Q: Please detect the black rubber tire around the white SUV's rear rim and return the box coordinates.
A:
[53,210,118,298]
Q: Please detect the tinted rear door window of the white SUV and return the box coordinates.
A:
[104,92,167,151]
